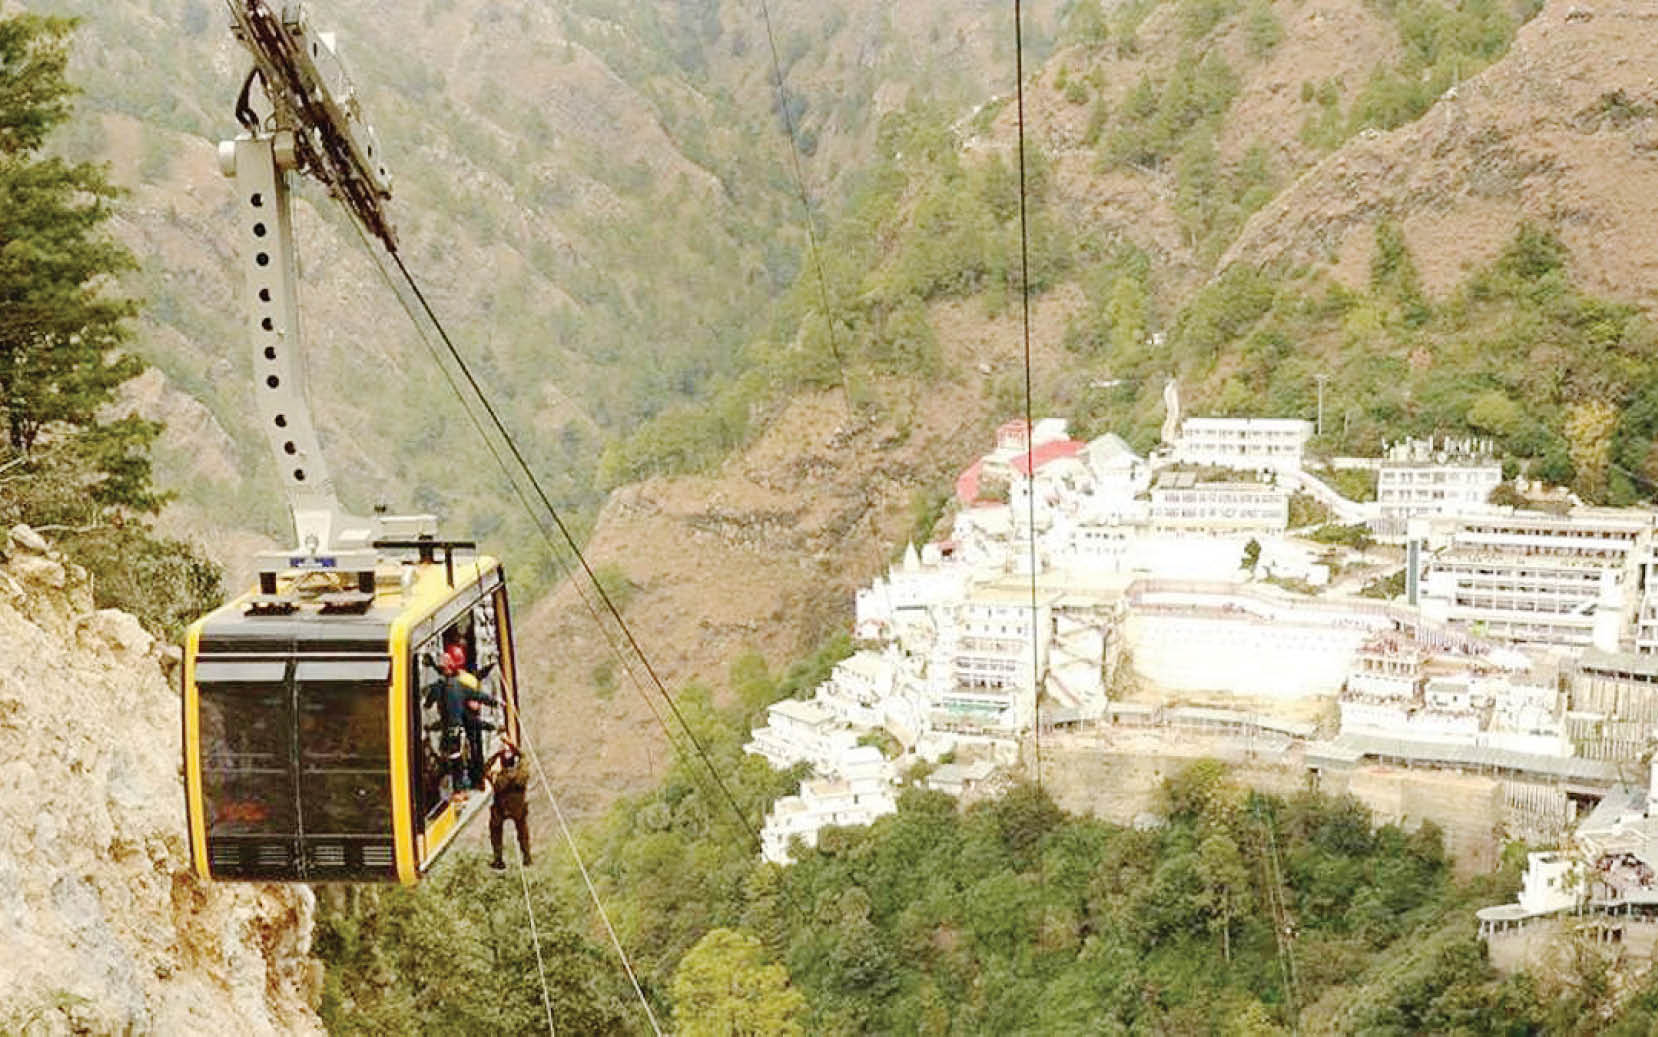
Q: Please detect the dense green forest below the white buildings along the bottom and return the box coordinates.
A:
[318,700,1658,1034]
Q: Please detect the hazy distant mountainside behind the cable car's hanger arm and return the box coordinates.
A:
[25,0,1061,589]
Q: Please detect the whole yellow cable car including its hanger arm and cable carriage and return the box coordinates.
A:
[182,0,519,883]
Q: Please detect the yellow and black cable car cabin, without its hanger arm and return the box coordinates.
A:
[184,551,519,884]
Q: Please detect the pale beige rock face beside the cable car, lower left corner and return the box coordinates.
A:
[0,537,322,1034]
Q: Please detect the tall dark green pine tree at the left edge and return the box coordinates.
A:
[0,15,150,497]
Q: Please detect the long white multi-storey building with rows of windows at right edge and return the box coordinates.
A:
[1423,508,1653,650]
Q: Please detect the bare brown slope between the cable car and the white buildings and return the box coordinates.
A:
[519,290,1079,808]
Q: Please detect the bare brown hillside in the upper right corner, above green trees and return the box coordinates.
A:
[1227,0,1658,309]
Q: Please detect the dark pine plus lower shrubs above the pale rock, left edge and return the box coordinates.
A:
[0,13,219,634]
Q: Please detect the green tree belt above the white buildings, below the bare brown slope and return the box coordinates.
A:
[1066,224,1658,504]
